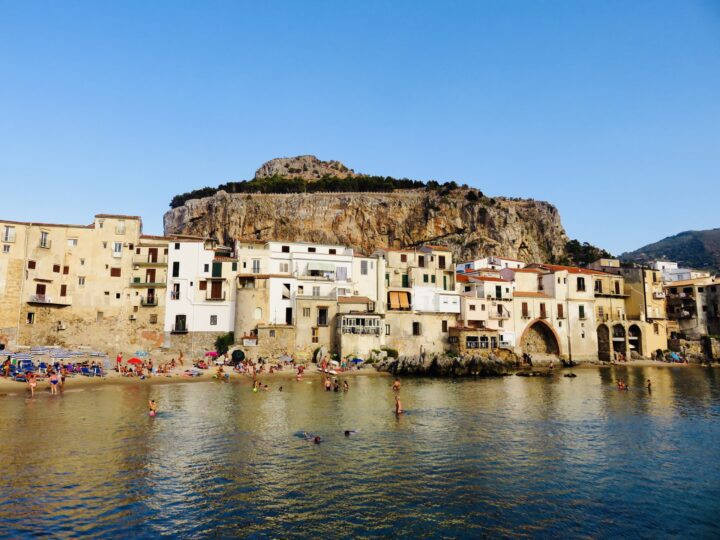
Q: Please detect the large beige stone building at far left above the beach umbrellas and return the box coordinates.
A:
[0,214,165,351]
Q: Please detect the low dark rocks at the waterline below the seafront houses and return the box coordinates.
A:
[375,354,515,377]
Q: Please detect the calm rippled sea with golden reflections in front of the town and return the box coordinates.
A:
[0,368,720,538]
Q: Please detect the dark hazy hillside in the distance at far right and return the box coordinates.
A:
[620,229,720,272]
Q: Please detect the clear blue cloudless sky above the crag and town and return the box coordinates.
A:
[0,0,720,253]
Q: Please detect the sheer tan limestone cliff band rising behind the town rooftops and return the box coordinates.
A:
[164,188,567,262]
